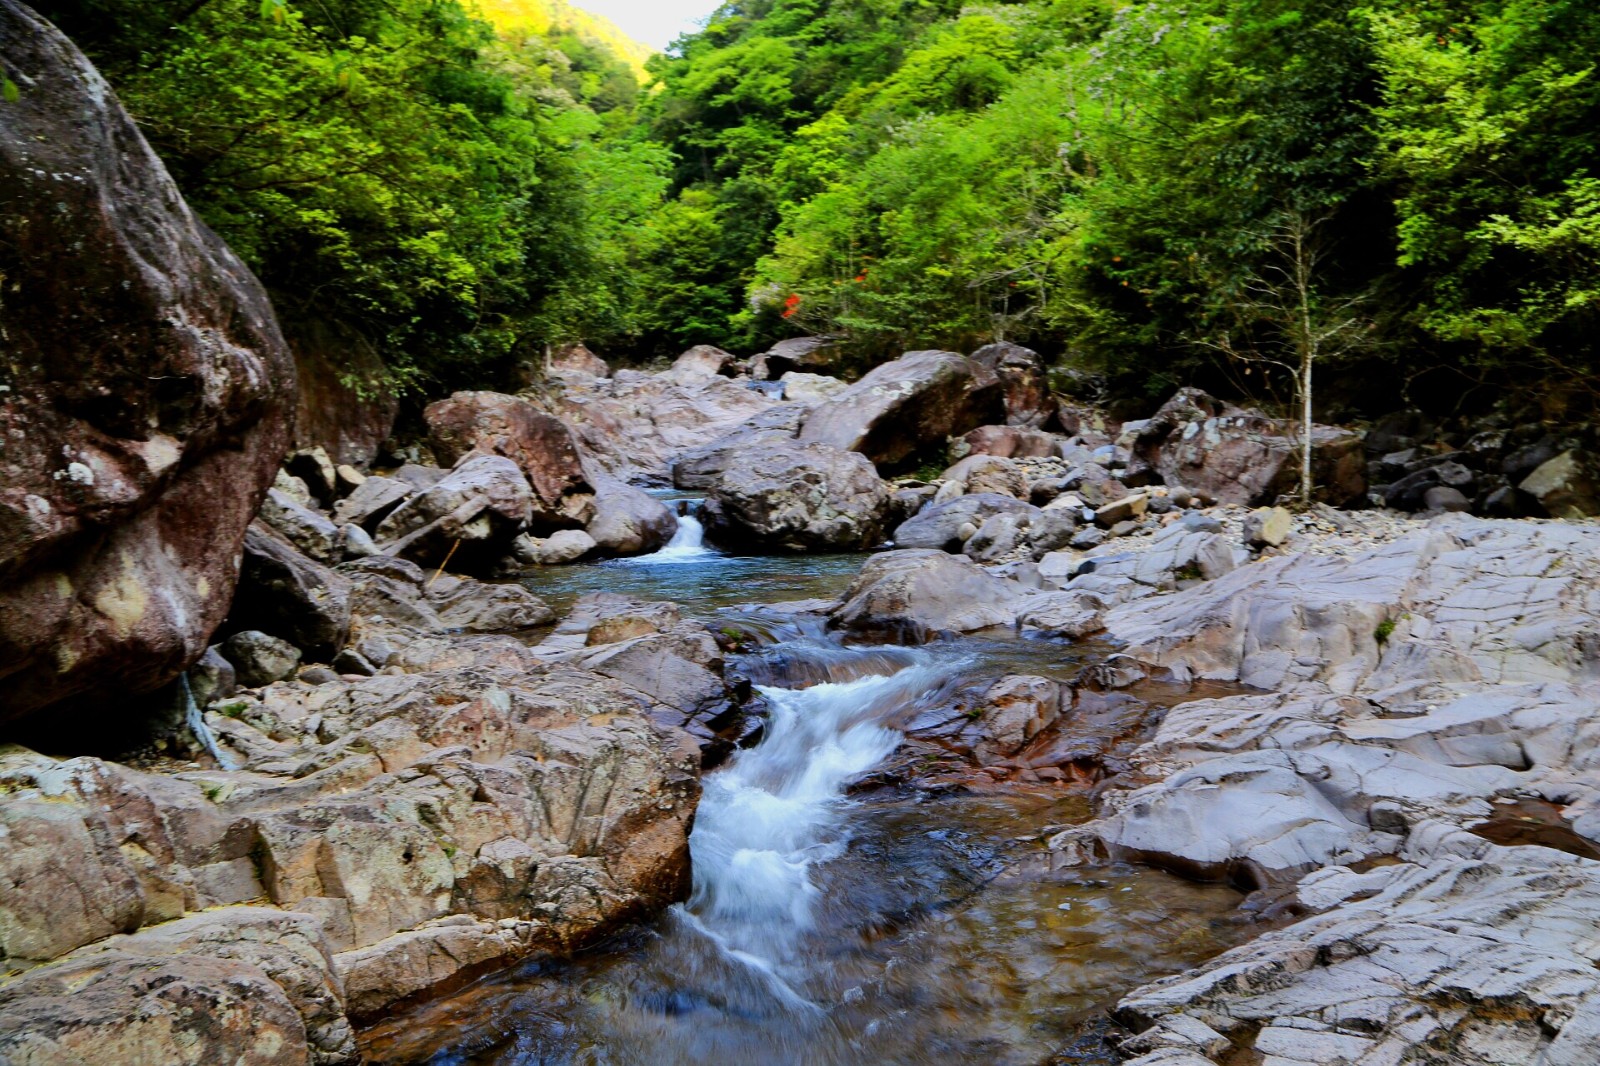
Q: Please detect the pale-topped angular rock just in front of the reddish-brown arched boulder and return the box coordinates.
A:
[374,455,533,571]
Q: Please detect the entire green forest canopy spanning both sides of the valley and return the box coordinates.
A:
[31,0,1600,416]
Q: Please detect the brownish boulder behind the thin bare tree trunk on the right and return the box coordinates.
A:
[1133,389,1366,506]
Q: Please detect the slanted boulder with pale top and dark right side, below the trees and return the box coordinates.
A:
[800,352,1005,471]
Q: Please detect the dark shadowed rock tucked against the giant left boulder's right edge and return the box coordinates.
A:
[227,523,350,659]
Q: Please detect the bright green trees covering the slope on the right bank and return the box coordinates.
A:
[648,0,1600,402]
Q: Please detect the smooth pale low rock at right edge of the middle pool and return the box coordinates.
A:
[829,549,1022,642]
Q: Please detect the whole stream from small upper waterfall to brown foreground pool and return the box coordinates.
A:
[362,505,1259,1066]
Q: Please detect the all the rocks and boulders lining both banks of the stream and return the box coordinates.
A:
[0,10,1600,1066]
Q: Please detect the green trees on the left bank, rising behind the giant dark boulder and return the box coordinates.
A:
[31,0,667,391]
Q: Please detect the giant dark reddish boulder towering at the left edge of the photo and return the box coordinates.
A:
[0,0,294,719]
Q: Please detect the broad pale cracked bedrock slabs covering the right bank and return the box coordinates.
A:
[1051,514,1600,1066]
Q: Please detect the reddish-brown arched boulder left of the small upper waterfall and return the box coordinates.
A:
[422,392,594,530]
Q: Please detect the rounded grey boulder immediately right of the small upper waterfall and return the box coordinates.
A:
[701,442,890,552]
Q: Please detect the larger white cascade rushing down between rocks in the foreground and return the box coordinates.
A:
[688,659,950,962]
